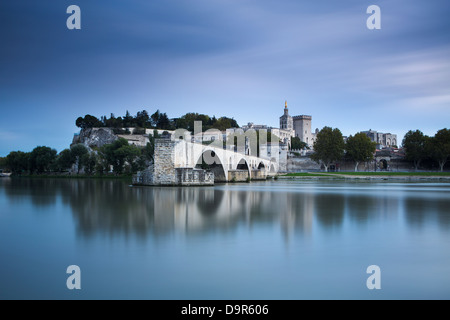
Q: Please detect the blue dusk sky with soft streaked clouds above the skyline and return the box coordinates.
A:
[0,0,450,156]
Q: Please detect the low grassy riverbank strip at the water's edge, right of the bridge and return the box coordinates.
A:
[278,172,450,182]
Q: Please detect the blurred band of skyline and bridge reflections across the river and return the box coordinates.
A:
[0,179,450,237]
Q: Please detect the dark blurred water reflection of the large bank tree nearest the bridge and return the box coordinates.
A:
[314,193,345,227]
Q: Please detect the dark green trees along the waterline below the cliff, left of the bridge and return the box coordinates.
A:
[0,132,159,175]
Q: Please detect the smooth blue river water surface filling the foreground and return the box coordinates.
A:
[0,178,450,299]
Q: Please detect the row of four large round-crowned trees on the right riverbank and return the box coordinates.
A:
[311,127,450,171]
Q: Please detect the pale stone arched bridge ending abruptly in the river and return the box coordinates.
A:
[133,139,285,185]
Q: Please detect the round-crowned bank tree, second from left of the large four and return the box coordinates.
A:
[345,132,376,172]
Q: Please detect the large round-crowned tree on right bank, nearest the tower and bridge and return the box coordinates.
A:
[311,127,345,172]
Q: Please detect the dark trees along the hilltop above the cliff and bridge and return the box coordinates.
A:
[75,110,239,132]
